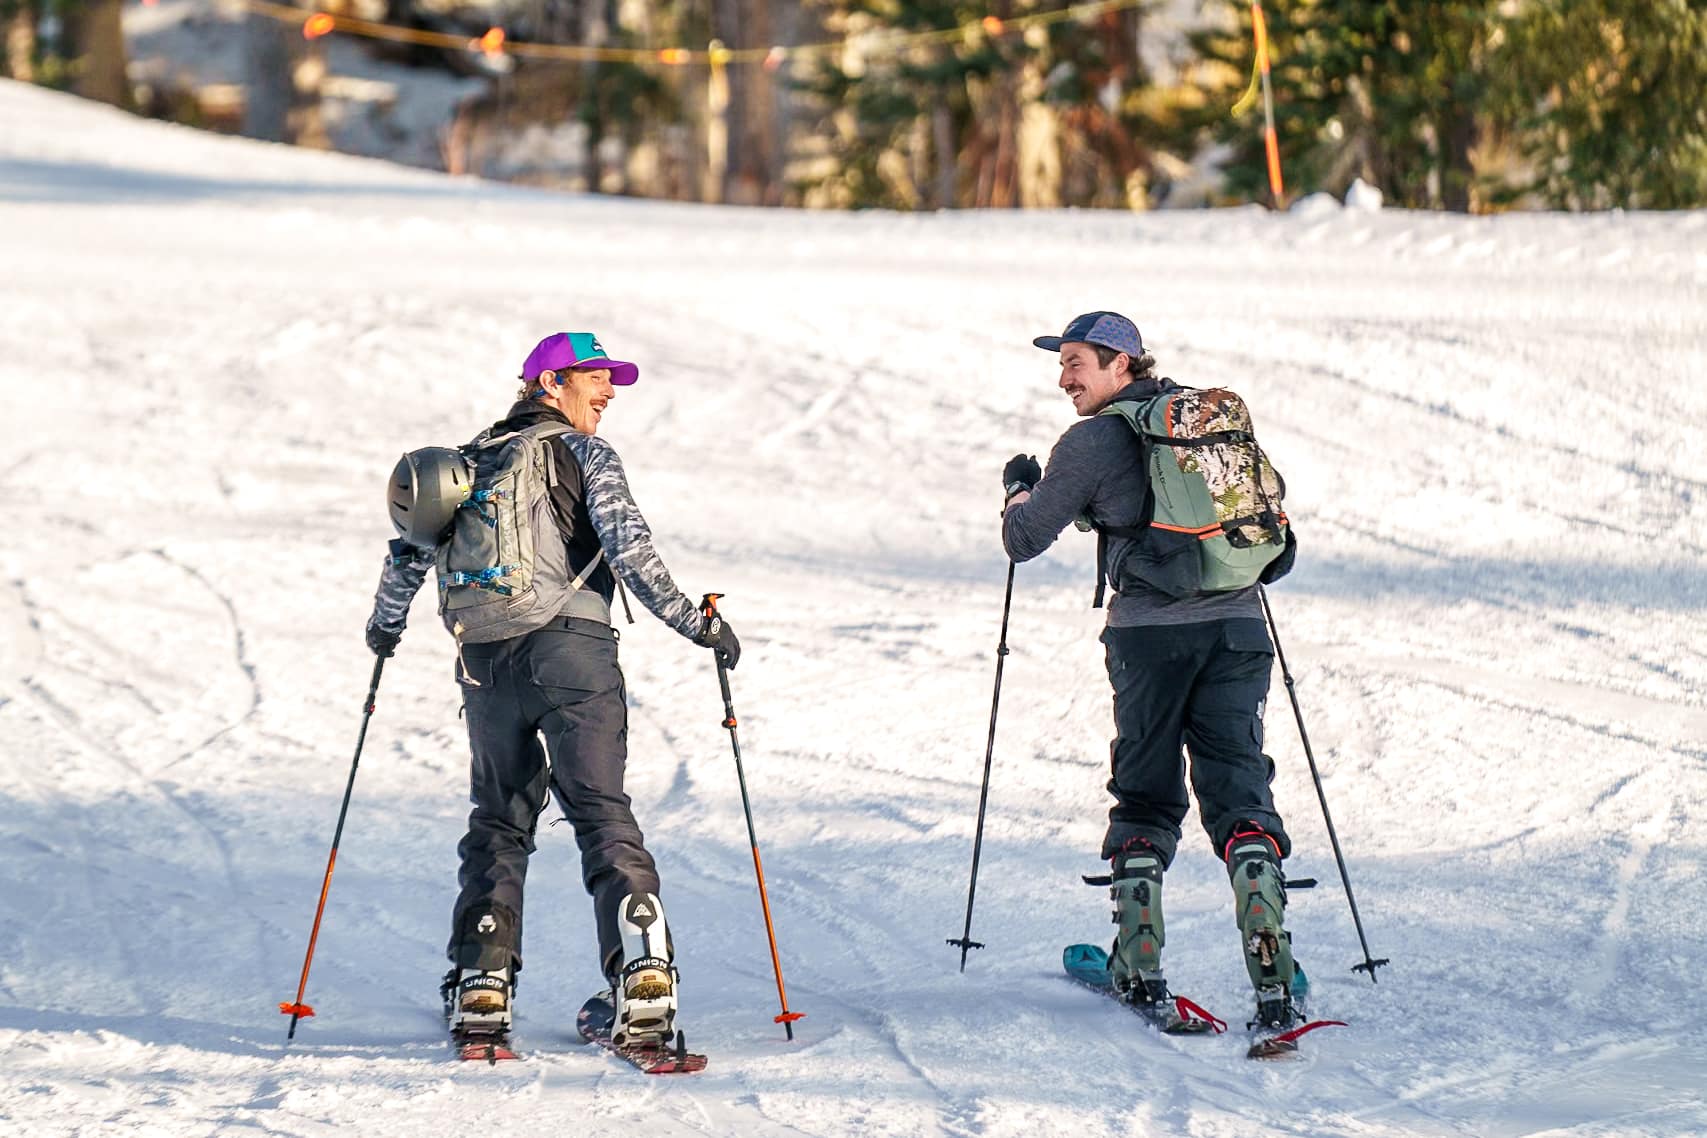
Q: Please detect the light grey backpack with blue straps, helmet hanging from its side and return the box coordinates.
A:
[439,423,604,645]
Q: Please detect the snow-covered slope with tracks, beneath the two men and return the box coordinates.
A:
[0,84,1707,1138]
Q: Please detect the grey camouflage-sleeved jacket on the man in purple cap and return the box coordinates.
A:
[367,414,705,640]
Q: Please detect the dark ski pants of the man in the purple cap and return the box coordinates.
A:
[449,616,659,971]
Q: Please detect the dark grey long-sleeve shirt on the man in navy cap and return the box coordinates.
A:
[1002,380,1263,628]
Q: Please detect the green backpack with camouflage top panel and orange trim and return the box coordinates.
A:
[1081,387,1292,604]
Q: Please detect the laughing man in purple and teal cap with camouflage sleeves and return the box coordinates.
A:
[367,333,741,1042]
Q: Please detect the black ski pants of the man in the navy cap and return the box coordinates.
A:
[1103,618,1292,867]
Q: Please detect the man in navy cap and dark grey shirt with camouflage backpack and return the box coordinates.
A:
[1002,312,1297,1029]
